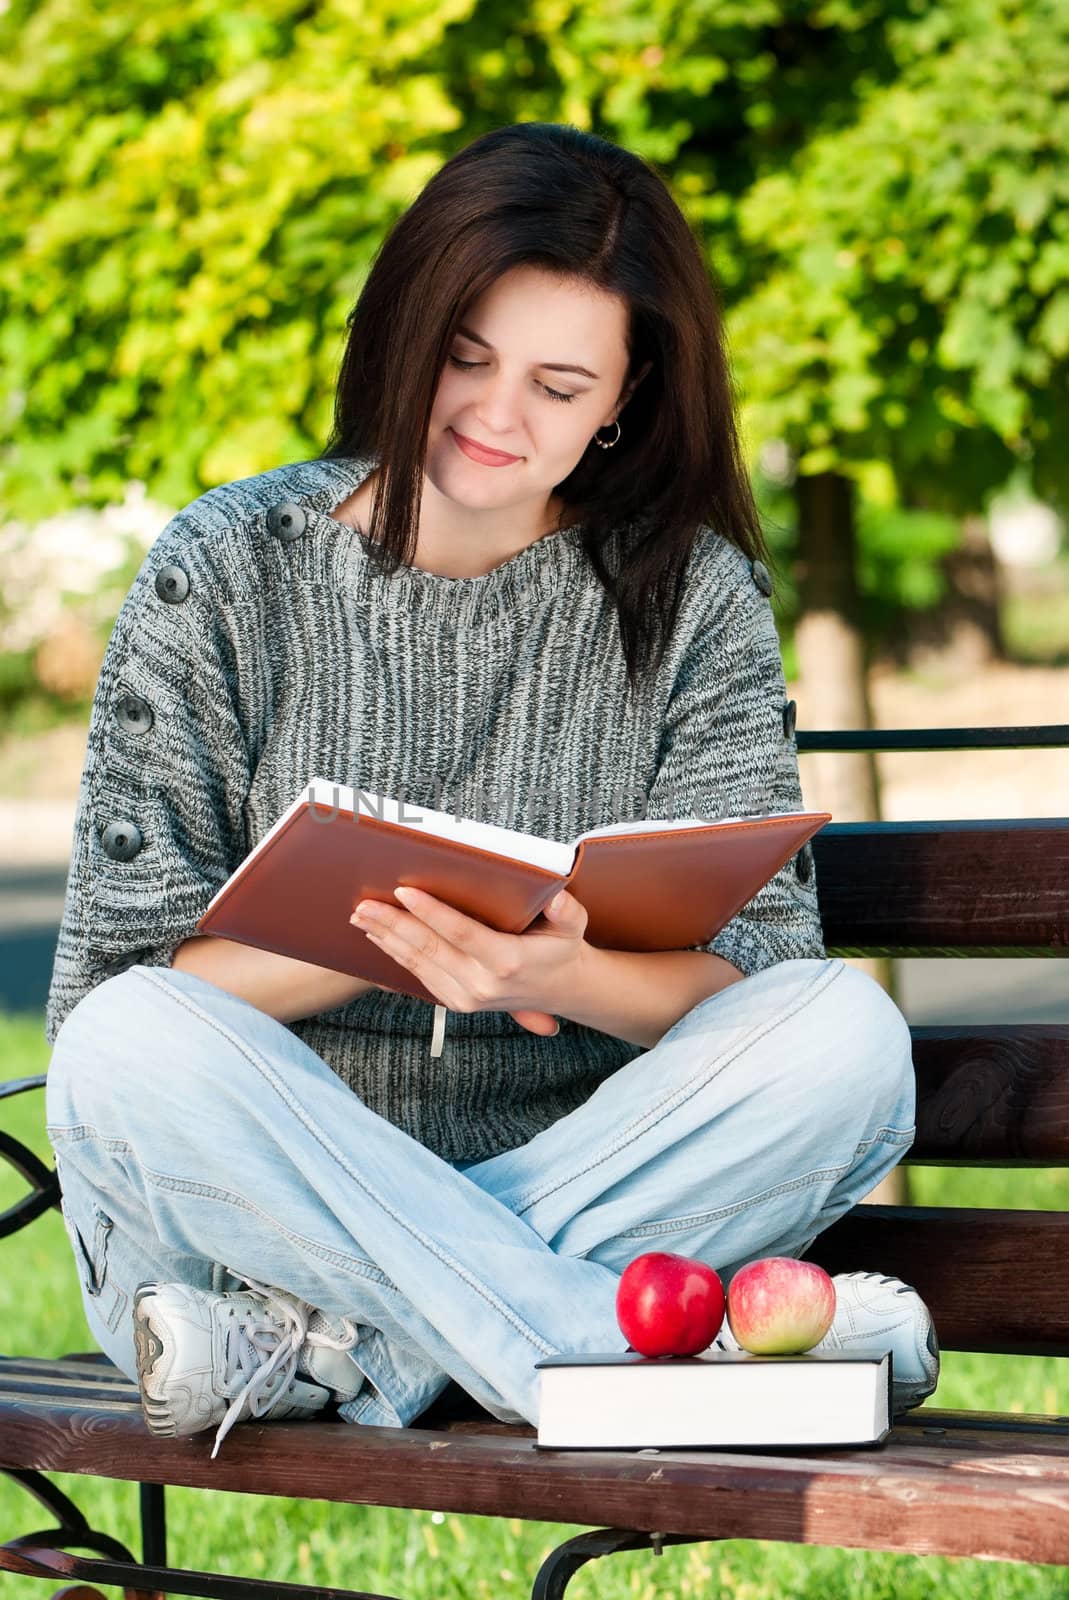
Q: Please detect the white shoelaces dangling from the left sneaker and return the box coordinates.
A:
[211,1272,358,1461]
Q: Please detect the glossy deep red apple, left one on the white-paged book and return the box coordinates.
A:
[616,1250,723,1355]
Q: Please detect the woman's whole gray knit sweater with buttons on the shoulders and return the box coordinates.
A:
[45,458,824,1162]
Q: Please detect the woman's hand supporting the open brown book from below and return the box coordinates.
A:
[349,888,587,1035]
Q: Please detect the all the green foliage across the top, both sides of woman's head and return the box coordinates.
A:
[0,0,1069,588]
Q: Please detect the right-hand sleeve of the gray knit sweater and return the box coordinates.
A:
[647,574,826,976]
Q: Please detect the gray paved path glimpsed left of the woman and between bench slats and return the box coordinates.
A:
[0,866,1069,1030]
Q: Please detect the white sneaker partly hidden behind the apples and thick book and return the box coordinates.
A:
[712,1272,939,1416]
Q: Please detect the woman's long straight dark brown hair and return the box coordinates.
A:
[323,122,773,694]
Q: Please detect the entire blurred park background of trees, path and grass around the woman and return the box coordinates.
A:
[0,0,1069,1600]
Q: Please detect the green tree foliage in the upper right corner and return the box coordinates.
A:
[731,0,1069,512]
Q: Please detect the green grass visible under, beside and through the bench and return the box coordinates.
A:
[0,1014,1069,1600]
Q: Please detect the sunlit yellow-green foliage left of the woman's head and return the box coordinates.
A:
[0,0,469,517]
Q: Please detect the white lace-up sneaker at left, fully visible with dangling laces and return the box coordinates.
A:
[133,1274,363,1461]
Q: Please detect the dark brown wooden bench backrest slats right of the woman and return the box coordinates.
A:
[797,726,1069,1355]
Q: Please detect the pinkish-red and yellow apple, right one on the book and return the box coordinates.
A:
[728,1256,835,1355]
